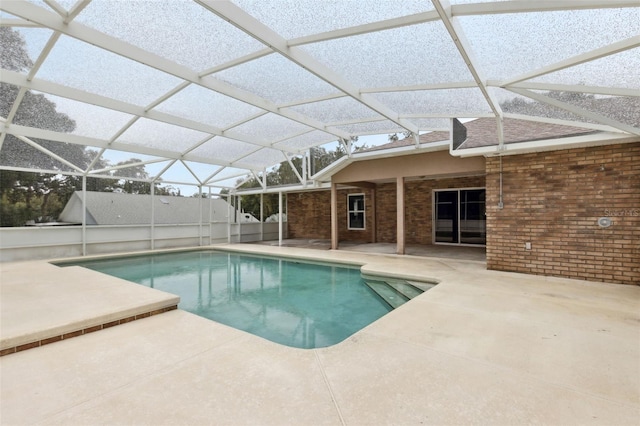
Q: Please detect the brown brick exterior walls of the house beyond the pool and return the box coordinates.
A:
[287,123,640,285]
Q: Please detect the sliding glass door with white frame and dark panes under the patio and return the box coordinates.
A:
[433,189,487,245]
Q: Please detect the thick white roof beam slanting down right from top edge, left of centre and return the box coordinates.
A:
[196,0,418,138]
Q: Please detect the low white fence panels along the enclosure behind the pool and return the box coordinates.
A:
[0,222,287,262]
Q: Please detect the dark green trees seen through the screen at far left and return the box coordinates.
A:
[0,27,179,226]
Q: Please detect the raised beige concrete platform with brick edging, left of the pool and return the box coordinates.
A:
[0,261,180,356]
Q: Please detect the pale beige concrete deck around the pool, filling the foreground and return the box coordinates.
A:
[0,244,640,425]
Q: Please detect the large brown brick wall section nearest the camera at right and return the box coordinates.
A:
[486,143,640,284]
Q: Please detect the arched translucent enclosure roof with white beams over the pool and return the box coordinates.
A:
[0,0,640,190]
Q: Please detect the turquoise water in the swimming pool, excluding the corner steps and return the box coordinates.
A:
[63,251,391,349]
